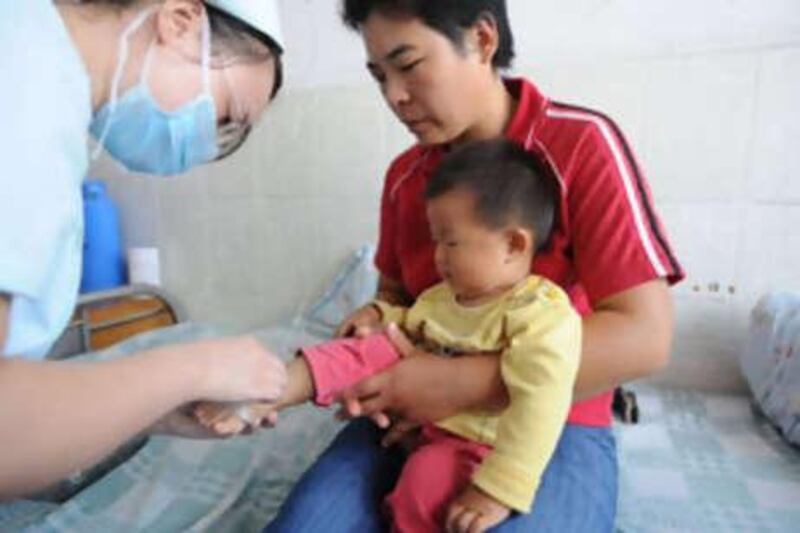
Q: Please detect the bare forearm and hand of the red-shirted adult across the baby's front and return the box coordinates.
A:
[341,324,508,430]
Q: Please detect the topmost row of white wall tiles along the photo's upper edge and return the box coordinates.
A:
[280,0,800,87]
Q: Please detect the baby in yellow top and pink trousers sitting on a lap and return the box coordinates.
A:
[197,140,581,532]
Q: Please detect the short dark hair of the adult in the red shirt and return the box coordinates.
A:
[342,0,514,69]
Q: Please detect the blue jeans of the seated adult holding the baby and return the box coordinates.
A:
[264,419,617,533]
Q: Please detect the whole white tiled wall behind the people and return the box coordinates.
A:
[96,0,800,389]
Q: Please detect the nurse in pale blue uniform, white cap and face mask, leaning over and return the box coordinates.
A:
[0,0,285,500]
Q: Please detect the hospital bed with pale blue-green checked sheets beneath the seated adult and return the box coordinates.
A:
[0,248,800,532]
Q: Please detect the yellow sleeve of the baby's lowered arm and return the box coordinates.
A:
[453,300,581,513]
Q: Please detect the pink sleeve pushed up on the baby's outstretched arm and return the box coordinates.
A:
[300,333,400,407]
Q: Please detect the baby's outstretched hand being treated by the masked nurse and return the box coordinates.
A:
[194,402,277,436]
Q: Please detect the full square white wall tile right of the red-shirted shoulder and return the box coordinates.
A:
[641,54,757,202]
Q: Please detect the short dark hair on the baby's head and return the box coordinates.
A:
[425,139,561,252]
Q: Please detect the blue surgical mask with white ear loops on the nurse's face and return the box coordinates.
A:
[90,8,219,176]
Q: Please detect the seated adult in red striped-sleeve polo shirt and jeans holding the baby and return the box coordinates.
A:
[268,0,683,532]
